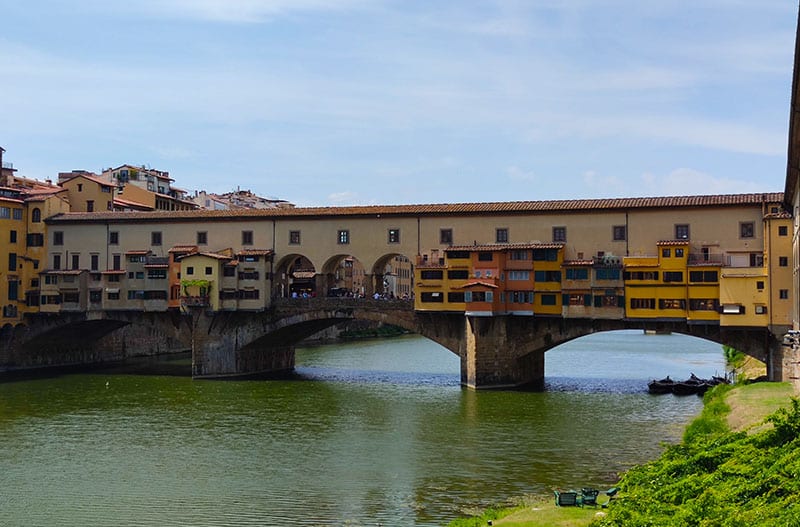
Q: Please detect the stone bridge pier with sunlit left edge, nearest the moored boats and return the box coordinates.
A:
[461,317,545,390]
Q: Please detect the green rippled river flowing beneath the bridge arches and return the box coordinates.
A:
[0,331,724,526]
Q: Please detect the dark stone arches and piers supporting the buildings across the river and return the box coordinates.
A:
[0,298,789,389]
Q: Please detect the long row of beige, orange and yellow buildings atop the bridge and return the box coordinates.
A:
[1,193,793,334]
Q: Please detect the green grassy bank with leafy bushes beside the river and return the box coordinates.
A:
[449,383,800,527]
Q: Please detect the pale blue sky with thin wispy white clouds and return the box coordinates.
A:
[0,0,798,206]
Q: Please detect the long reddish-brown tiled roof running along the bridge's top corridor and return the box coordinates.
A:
[47,192,783,223]
